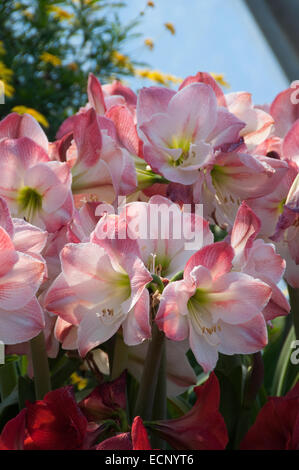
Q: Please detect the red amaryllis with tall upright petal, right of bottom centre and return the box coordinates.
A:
[151,373,228,450]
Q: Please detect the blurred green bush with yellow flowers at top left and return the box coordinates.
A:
[0,0,145,138]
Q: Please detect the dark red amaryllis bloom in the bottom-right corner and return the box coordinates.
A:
[241,382,299,450]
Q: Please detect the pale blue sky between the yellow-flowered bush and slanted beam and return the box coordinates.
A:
[121,0,288,104]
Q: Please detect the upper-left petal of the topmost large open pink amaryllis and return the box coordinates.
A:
[137,87,175,126]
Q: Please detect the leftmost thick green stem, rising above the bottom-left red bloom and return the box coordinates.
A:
[30,331,51,400]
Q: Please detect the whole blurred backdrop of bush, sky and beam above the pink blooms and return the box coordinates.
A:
[0,0,299,138]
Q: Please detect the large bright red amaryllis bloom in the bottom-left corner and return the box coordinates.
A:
[0,387,98,450]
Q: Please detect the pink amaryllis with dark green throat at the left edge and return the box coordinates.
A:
[0,137,73,232]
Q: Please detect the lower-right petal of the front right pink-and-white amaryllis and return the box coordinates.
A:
[217,314,268,355]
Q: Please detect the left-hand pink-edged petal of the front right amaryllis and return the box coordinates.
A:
[155,281,192,341]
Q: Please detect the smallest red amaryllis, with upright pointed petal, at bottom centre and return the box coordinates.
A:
[96,416,152,450]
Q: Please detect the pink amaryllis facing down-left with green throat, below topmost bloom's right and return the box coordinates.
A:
[198,152,288,227]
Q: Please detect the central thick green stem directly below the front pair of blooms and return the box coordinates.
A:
[135,323,164,421]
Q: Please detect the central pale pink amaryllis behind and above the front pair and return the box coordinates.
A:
[120,196,213,279]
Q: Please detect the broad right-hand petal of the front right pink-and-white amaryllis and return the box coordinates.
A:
[208,272,272,325]
